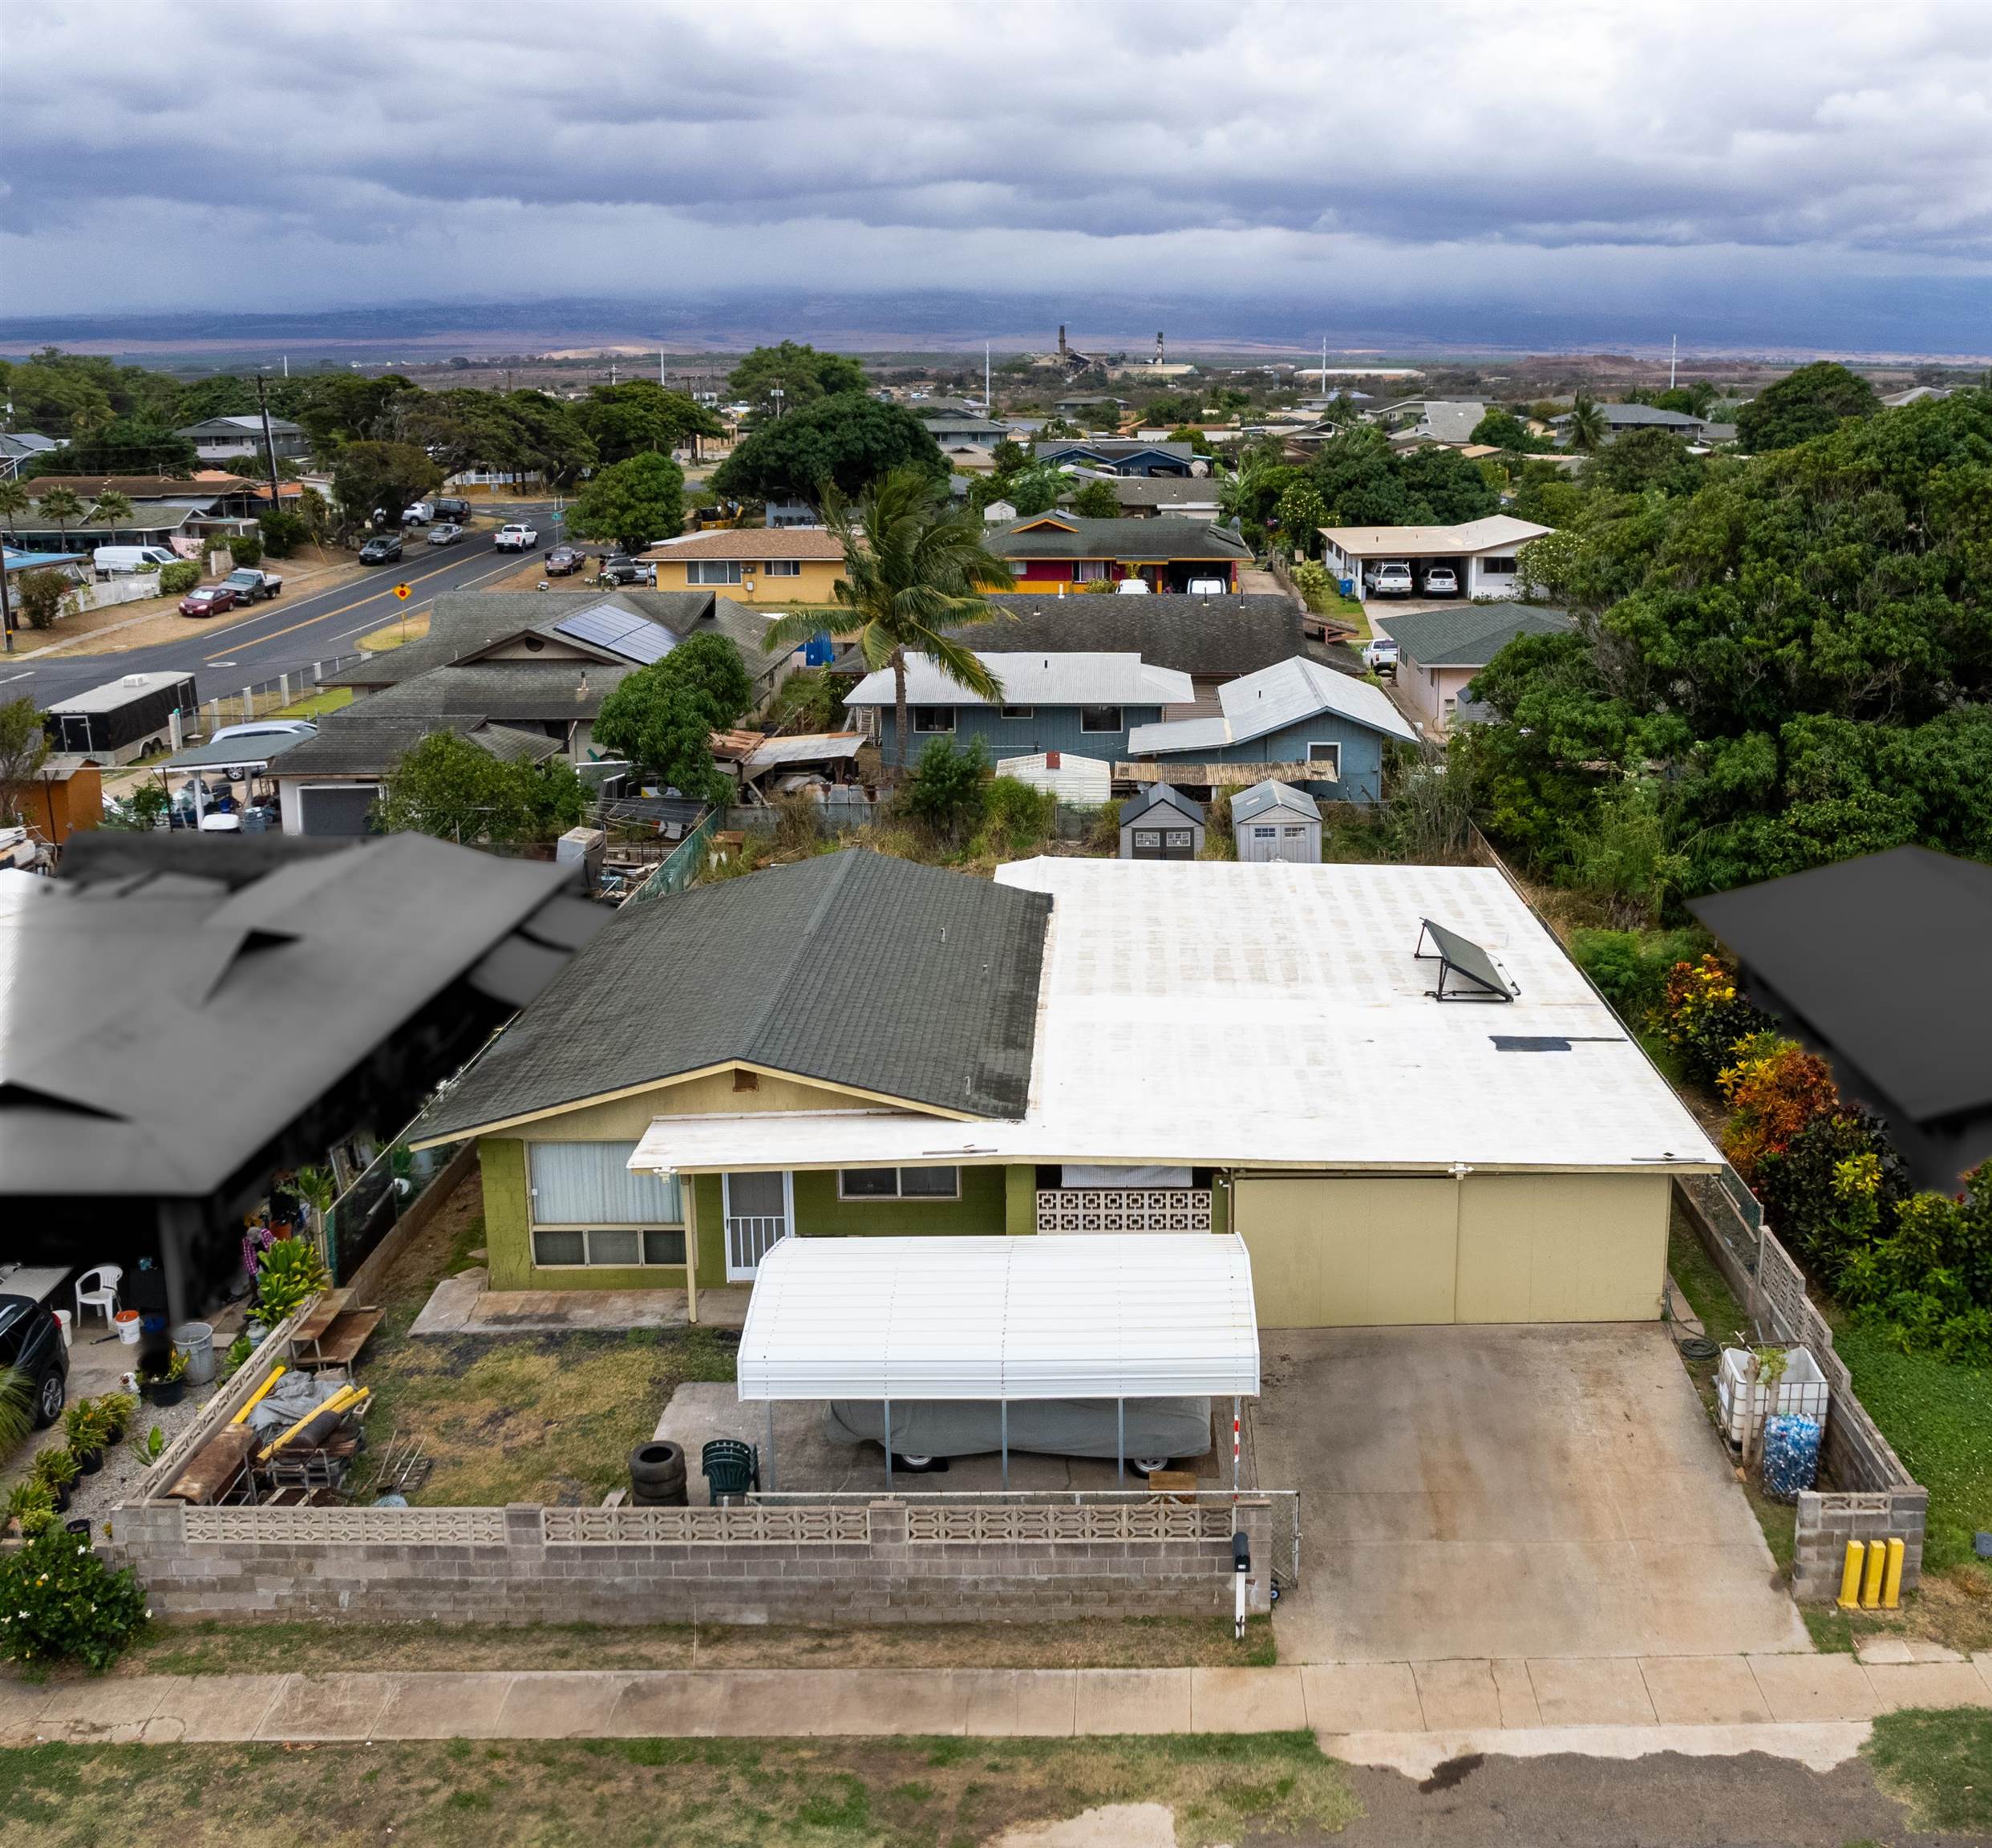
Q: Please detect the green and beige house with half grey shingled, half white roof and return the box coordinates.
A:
[416,850,1719,1327]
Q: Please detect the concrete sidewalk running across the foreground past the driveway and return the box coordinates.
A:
[0,1655,1992,1769]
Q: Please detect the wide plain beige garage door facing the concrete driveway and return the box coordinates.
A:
[1235,1175,1671,1328]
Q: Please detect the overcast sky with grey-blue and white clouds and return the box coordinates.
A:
[0,0,1992,351]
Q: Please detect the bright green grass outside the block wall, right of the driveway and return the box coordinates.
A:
[1832,1320,1992,1571]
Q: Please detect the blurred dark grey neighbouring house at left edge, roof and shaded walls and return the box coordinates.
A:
[0,829,605,1323]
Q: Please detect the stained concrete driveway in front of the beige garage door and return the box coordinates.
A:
[1253,1323,1811,1663]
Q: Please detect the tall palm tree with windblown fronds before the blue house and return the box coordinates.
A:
[767,468,1016,776]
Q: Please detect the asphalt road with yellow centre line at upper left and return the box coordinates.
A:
[0,508,561,709]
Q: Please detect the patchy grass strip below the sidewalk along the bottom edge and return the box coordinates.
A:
[0,1732,1361,1848]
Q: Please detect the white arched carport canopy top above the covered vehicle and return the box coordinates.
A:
[739,1233,1259,1400]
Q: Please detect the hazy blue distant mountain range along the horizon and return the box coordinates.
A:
[0,277,1992,364]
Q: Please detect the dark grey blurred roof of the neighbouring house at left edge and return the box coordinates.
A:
[0,830,597,1199]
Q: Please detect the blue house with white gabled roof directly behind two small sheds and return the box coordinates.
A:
[1114,655,1416,803]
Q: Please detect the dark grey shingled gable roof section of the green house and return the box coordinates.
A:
[412,849,1052,1139]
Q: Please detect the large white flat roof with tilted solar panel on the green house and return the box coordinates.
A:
[631,858,1721,1171]
